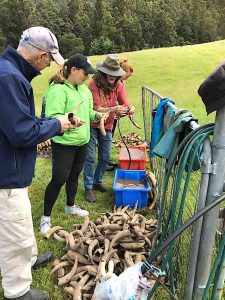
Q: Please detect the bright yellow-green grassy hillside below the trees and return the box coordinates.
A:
[33,40,225,130]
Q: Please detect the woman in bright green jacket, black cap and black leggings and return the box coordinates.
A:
[40,53,101,234]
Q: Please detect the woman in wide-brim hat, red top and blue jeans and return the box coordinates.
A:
[84,54,134,202]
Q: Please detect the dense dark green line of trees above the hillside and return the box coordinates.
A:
[0,0,225,57]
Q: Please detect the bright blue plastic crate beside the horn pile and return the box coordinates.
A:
[113,170,151,208]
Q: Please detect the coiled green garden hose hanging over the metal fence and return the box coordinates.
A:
[144,124,218,299]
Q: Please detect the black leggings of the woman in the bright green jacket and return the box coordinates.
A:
[44,142,87,216]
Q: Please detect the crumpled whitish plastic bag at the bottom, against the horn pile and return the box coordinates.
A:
[94,263,142,300]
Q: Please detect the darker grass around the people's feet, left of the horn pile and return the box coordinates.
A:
[30,158,117,300]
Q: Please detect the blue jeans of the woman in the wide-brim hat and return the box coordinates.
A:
[84,128,112,190]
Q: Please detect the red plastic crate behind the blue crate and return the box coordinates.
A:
[119,146,148,170]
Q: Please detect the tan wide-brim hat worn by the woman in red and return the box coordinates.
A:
[96,54,126,77]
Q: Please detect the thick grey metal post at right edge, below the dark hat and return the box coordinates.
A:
[193,107,225,300]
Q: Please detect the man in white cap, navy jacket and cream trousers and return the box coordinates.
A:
[0,27,78,300]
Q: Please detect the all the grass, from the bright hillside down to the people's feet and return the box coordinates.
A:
[1,41,225,300]
